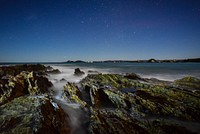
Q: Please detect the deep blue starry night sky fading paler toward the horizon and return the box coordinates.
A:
[0,0,200,62]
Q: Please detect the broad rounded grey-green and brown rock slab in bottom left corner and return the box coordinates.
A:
[0,96,70,134]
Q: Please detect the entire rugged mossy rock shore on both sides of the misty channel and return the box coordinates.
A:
[0,64,200,134]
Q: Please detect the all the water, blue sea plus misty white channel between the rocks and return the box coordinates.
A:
[45,63,200,134]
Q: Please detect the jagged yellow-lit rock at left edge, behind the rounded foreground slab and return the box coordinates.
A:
[0,72,52,105]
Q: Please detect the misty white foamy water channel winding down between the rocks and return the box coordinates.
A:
[49,66,94,134]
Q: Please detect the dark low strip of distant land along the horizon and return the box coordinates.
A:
[65,58,200,63]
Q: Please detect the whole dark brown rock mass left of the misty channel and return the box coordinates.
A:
[0,64,71,134]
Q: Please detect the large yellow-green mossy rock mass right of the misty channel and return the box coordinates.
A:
[61,74,200,134]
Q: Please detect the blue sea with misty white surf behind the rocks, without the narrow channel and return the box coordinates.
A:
[47,62,200,82]
